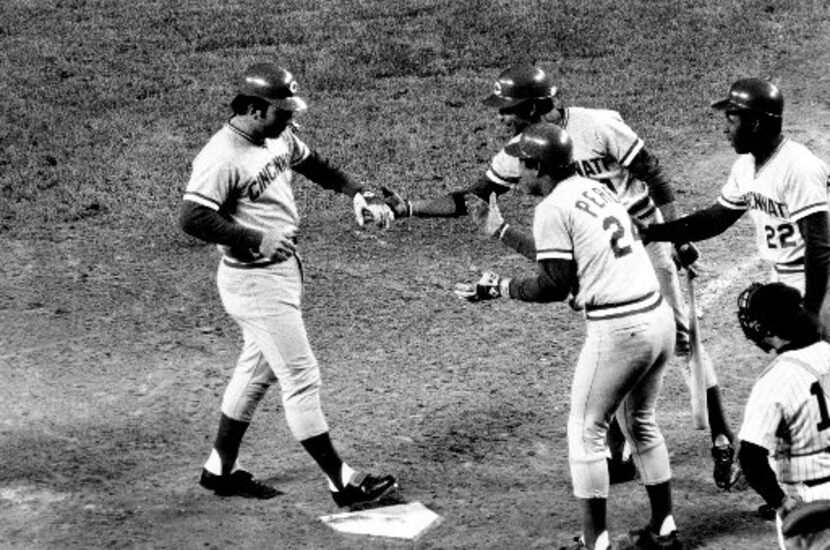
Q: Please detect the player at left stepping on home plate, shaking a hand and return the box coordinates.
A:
[180,63,396,506]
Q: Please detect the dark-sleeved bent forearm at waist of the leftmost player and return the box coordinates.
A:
[179,200,262,249]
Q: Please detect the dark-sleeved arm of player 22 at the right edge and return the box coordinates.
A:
[798,211,830,315]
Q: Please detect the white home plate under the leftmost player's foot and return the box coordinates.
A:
[320,502,441,540]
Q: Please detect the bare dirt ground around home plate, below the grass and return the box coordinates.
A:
[0,43,830,549]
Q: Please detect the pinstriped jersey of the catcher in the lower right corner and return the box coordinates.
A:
[738,341,830,483]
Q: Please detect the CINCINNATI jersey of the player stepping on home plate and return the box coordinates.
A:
[184,124,311,265]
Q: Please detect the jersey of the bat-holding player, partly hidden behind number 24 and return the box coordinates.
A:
[486,107,656,219]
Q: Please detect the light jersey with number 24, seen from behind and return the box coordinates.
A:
[533,175,659,310]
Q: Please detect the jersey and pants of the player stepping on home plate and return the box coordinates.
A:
[184,124,328,440]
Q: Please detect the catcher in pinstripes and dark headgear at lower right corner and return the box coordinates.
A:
[738,283,830,548]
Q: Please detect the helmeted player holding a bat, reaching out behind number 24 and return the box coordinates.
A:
[386,64,736,487]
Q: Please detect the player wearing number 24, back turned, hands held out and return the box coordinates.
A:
[456,123,681,550]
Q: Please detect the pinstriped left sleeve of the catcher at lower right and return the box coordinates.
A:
[738,365,786,453]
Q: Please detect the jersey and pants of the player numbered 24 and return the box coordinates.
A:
[533,175,674,498]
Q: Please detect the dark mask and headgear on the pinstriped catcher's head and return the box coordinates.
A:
[738,283,808,352]
